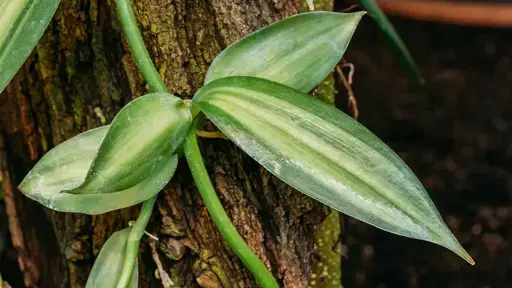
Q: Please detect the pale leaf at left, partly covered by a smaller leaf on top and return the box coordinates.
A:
[19,126,178,214]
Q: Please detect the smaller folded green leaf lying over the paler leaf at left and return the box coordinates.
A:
[70,93,192,194]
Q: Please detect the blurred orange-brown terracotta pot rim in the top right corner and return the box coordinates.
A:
[377,0,512,27]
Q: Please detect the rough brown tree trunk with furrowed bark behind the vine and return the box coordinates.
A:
[0,0,329,287]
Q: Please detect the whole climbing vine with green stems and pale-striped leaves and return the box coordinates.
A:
[0,0,473,287]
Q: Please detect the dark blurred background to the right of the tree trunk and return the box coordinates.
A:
[336,1,512,288]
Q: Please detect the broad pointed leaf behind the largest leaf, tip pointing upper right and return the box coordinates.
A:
[205,12,364,92]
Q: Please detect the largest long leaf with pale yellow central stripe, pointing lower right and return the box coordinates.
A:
[192,77,473,263]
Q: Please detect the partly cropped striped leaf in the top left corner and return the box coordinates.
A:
[0,0,60,92]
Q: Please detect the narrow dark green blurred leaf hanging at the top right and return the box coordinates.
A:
[361,0,425,87]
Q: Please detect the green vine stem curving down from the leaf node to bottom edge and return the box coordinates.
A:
[183,125,279,288]
